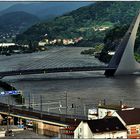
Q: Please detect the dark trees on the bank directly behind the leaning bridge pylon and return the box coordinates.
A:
[99,25,140,63]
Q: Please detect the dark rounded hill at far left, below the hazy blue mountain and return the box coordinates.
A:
[0,12,39,40]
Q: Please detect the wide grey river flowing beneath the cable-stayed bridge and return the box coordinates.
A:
[0,48,140,114]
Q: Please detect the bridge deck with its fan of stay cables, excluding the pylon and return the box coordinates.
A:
[0,48,108,77]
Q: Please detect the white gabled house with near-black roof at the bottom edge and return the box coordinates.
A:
[74,117,127,139]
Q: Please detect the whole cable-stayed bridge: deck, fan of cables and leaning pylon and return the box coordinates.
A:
[0,10,140,78]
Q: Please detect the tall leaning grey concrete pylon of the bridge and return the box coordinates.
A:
[104,12,140,76]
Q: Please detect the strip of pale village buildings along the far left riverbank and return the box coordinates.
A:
[0,37,83,55]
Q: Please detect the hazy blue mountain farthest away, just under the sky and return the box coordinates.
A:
[0,1,93,19]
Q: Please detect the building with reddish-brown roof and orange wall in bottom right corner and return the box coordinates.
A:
[113,108,140,138]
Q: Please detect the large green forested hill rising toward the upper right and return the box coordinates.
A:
[16,1,140,45]
